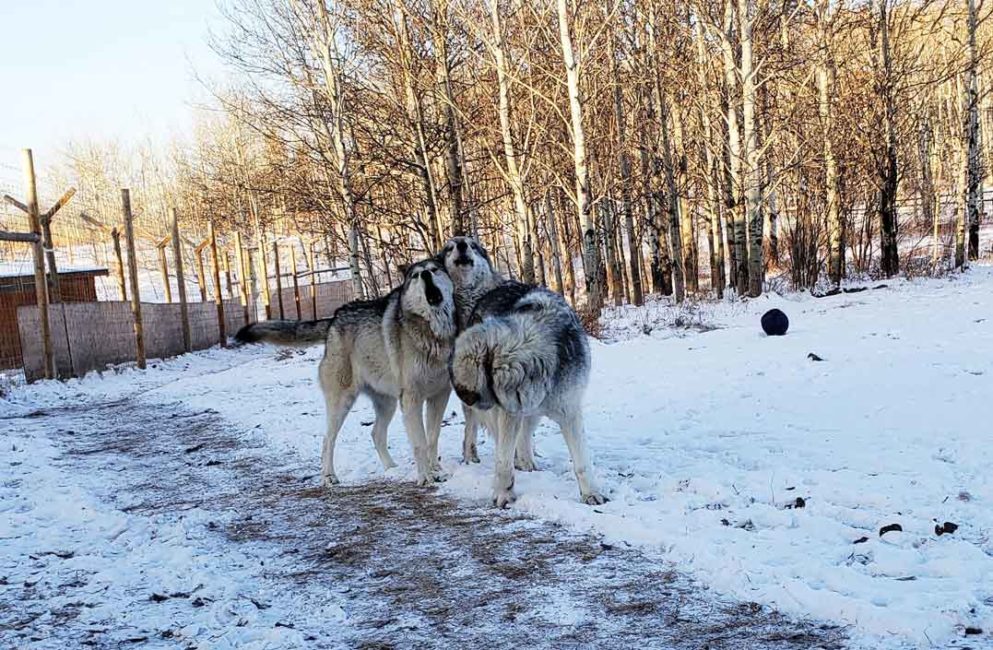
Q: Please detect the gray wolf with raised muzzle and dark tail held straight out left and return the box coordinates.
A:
[236,259,455,485]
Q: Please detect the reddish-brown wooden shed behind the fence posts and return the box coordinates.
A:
[0,268,107,370]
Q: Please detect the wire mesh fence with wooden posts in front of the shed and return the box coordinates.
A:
[0,171,352,381]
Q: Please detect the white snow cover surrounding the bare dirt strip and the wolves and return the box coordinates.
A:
[0,267,993,648]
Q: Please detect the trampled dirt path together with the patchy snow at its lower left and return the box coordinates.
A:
[0,398,844,649]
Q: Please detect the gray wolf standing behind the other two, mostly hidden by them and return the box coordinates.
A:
[438,236,536,472]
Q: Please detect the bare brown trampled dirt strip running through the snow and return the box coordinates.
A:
[0,400,846,648]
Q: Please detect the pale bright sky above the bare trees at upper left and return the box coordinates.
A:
[0,0,224,175]
